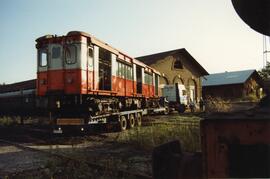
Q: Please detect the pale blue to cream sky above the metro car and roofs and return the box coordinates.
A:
[0,0,263,84]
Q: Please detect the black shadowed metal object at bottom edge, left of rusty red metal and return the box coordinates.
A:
[152,140,202,179]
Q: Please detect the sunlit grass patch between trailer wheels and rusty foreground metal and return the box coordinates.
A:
[118,115,201,152]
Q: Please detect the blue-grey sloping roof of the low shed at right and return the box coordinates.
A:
[202,70,257,87]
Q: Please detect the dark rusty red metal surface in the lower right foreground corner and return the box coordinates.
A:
[201,109,270,178]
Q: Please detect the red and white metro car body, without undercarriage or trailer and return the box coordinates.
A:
[36,31,160,98]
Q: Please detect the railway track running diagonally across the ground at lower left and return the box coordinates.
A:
[0,139,152,179]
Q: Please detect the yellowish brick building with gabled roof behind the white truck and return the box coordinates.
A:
[136,48,208,102]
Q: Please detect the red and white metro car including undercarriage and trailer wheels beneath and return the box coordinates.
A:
[36,31,165,129]
